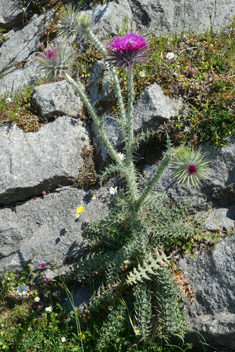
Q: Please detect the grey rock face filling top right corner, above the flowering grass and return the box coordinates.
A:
[129,0,235,34]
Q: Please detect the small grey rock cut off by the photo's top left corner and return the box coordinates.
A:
[0,0,24,29]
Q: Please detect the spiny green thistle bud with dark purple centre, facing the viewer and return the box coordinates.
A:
[172,147,209,187]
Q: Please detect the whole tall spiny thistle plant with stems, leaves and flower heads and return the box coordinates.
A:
[37,7,208,347]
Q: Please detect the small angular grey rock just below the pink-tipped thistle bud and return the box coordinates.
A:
[33,81,82,119]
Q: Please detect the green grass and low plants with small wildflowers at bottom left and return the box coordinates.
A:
[0,265,194,352]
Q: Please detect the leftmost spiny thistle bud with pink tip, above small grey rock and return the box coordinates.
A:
[38,46,74,80]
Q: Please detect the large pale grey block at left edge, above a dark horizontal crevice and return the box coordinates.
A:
[0,116,89,206]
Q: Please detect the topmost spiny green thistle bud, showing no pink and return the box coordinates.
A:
[57,5,91,37]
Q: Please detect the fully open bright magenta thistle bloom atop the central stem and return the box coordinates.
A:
[106,33,149,67]
